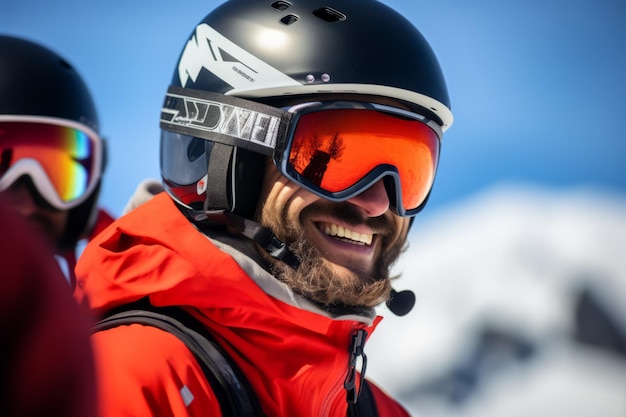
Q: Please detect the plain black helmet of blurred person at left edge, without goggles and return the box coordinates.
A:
[0,35,104,246]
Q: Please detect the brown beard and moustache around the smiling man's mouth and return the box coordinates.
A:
[261,198,407,308]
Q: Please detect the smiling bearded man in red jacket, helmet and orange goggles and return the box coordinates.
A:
[76,0,452,417]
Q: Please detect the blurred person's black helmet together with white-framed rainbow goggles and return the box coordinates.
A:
[0,35,105,245]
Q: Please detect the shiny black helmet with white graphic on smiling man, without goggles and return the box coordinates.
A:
[160,0,453,219]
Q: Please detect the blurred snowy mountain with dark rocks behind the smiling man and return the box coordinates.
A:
[366,185,626,417]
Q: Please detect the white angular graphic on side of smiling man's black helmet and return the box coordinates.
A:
[178,23,301,93]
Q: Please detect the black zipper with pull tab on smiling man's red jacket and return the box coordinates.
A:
[320,329,367,417]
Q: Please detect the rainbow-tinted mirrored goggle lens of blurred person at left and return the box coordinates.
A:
[0,121,97,203]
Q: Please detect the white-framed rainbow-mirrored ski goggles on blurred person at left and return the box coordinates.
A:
[0,115,103,210]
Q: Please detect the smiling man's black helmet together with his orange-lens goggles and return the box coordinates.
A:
[161,0,453,221]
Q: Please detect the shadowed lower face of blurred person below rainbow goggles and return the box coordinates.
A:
[2,181,68,250]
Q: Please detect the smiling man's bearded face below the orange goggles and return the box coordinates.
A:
[255,162,409,307]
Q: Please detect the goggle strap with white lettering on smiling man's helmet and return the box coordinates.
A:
[161,92,280,149]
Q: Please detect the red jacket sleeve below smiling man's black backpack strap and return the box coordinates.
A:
[92,324,222,417]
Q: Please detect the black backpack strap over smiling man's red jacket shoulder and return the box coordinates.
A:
[92,300,263,417]
